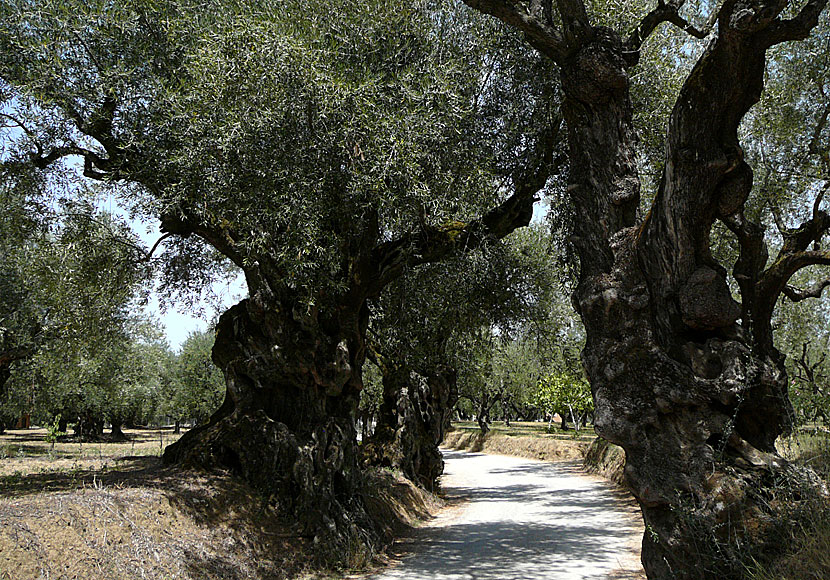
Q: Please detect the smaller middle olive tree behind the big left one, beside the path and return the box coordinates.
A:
[361,225,554,488]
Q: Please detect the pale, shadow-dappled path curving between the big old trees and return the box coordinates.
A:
[371,450,644,580]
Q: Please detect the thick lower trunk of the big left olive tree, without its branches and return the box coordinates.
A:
[164,294,378,562]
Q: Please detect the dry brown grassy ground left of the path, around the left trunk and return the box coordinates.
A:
[0,430,437,580]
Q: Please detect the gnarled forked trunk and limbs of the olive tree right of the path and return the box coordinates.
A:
[467,0,830,580]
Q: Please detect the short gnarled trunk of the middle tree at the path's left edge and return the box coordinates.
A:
[361,365,458,489]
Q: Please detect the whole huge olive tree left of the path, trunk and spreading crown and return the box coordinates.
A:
[0,0,558,559]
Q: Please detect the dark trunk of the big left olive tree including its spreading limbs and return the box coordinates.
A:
[158,172,551,564]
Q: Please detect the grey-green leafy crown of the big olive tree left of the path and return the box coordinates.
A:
[0,0,553,310]
